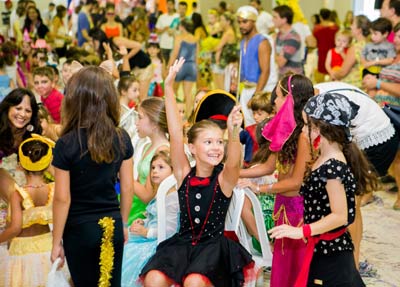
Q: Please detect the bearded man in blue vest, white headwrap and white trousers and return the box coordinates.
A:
[236,6,277,126]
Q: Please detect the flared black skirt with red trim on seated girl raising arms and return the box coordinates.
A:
[140,234,254,287]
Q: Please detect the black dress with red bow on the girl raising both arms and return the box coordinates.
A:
[141,165,253,287]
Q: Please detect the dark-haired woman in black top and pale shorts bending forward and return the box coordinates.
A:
[89,28,153,101]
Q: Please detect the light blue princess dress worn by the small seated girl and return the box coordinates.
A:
[121,192,179,287]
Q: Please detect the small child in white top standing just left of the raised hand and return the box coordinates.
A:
[147,42,165,97]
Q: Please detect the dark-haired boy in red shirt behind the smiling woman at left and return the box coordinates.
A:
[33,67,64,124]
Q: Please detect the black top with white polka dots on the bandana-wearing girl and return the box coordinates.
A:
[300,159,356,255]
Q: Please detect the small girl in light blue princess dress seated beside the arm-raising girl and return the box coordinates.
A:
[121,150,179,287]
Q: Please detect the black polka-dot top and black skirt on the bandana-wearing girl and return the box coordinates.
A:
[300,159,365,287]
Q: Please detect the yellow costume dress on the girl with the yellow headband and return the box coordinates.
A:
[5,183,69,287]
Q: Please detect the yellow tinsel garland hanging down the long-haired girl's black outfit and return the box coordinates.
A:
[98,217,115,287]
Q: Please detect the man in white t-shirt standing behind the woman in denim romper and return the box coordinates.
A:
[156,0,179,63]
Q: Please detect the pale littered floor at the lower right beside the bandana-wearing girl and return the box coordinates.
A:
[257,191,400,287]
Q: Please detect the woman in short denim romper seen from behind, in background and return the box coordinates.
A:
[168,20,199,116]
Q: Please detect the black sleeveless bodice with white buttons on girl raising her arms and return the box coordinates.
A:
[178,164,230,242]
